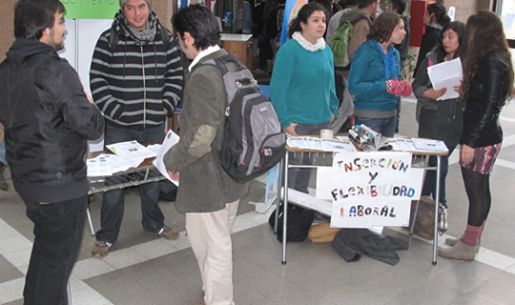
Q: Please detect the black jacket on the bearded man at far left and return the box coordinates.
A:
[0,39,104,202]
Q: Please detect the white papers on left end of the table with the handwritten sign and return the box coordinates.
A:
[286,136,356,152]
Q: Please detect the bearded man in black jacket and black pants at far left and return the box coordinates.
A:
[0,0,104,305]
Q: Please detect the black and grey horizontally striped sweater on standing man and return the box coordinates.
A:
[90,15,183,129]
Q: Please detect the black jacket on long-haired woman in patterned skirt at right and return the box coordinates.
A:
[460,53,511,147]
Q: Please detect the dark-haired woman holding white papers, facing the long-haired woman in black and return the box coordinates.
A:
[413,21,465,231]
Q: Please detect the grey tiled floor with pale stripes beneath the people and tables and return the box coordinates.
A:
[0,100,515,305]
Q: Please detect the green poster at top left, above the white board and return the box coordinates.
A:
[61,0,120,19]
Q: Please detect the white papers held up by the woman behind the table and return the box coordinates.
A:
[427,57,463,100]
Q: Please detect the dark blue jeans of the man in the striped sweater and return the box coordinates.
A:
[96,124,164,243]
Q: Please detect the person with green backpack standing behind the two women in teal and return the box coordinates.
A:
[326,0,380,132]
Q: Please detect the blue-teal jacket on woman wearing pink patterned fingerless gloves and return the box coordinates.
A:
[349,39,400,112]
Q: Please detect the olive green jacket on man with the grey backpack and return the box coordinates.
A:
[164,50,248,213]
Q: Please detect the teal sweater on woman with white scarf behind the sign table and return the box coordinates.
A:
[270,39,339,128]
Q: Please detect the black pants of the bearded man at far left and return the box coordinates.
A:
[23,195,88,305]
